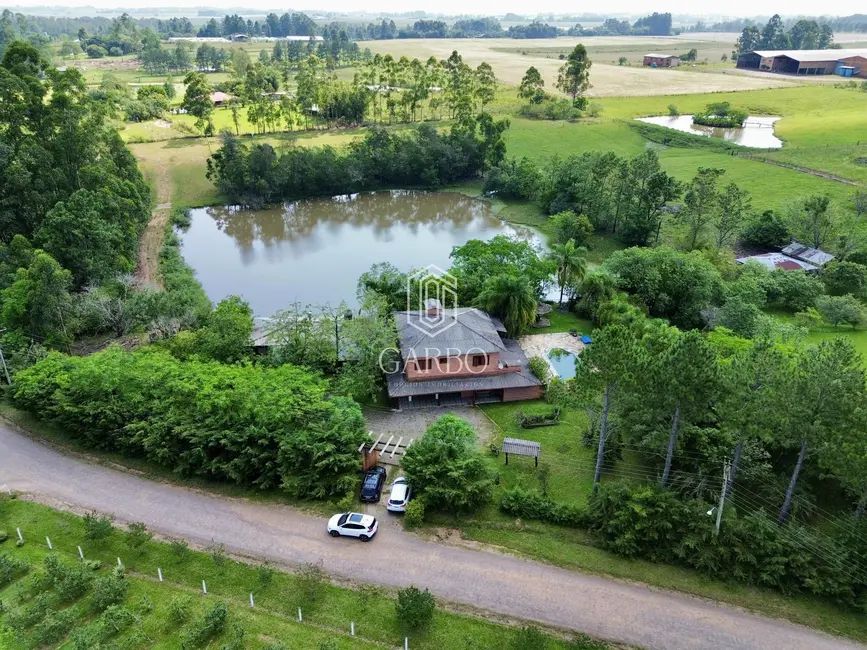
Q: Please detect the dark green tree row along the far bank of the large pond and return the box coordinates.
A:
[208,113,508,205]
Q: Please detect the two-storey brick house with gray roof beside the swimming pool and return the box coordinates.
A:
[386,300,543,408]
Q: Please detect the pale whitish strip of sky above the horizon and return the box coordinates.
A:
[0,0,867,18]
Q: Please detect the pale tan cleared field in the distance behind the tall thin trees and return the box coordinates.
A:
[365,36,793,97]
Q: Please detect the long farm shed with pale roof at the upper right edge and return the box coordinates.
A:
[740,48,867,78]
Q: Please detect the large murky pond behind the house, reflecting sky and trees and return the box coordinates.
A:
[182,191,542,316]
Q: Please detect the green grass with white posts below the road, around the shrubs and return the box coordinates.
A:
[0,497,604,650]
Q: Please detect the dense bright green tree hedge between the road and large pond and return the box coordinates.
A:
[14,346,367,498]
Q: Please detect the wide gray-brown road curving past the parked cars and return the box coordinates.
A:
[0,424,863,650]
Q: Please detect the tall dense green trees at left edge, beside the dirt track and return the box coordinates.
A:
[0,42,151,342]
